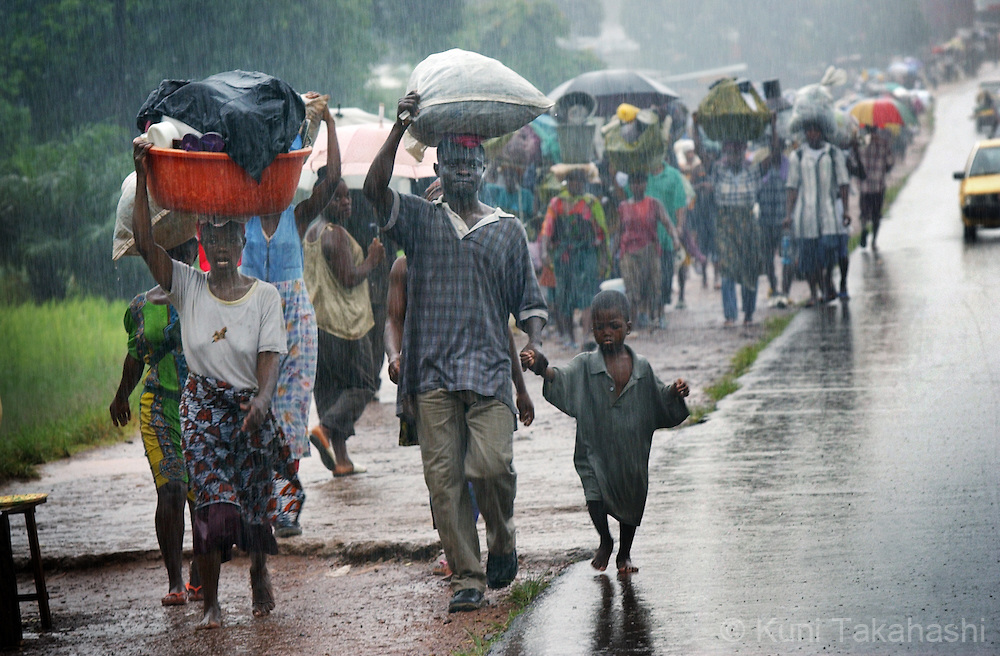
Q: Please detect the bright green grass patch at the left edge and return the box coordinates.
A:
[0,298,127,482]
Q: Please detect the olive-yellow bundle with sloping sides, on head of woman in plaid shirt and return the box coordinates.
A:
[698,78,771,141]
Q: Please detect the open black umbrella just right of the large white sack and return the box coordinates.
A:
[549,68,680,116]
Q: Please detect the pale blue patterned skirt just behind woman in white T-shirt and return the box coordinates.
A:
[271,278,317,460]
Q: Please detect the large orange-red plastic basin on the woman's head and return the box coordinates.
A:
[149,147,312,216]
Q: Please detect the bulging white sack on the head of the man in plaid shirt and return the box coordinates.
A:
[405,48,552,160]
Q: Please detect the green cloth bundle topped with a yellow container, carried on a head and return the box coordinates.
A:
[601,103,670,174]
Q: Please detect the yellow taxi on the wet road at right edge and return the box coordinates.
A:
[955,139,1000,242]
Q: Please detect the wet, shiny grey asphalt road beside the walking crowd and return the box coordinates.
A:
[494,83,1000,655]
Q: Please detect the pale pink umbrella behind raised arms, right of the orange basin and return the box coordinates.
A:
[305,122,437,180]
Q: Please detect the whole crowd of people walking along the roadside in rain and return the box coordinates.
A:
[110,50,928,628]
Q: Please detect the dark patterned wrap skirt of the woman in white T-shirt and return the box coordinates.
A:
[180,373,298,560]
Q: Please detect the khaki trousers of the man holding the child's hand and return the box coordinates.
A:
[417,389,517,592]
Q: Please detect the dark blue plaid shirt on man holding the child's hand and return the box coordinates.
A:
[383,191,548,414]
